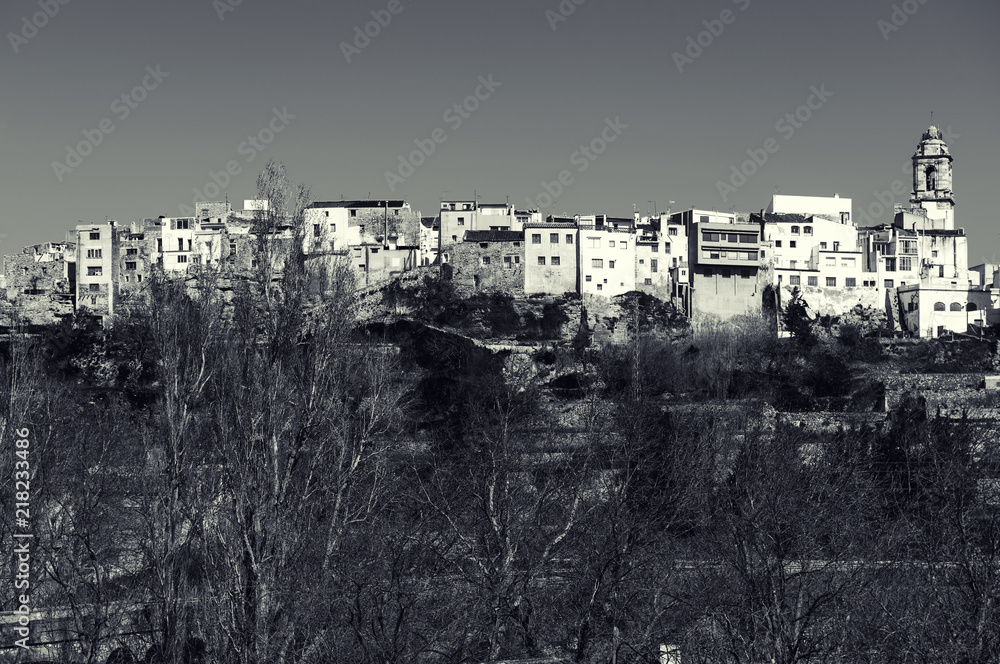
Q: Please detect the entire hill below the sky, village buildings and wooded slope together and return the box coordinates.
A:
[0,127,1000,664]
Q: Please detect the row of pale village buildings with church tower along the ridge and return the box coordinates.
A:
[0,126,1000,338]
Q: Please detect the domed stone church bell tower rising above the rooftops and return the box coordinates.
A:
[910,126,955,230]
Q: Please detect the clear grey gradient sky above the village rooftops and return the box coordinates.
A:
[0,0,1000,265]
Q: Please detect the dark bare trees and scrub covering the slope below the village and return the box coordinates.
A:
[0,166,1000,664]
